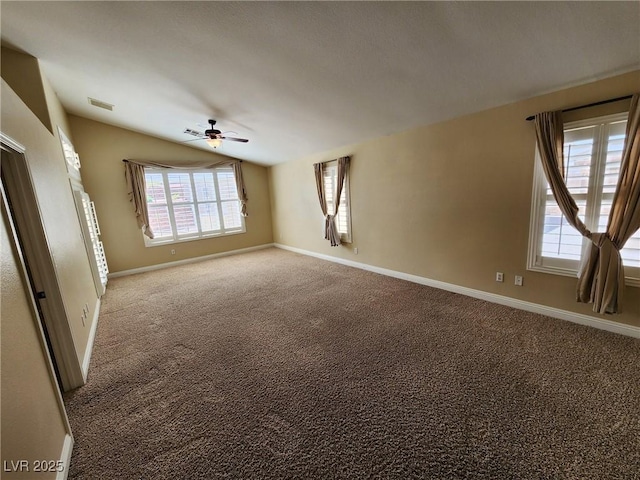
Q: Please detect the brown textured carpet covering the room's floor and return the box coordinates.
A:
[65,249,640,480]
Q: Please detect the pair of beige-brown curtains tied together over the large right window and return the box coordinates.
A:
[535,94,640,313]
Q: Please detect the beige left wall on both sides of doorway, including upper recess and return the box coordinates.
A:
[0,49,106,478]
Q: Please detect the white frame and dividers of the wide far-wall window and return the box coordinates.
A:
[143,167,247,247]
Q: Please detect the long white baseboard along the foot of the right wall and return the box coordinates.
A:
[274,243,640,338]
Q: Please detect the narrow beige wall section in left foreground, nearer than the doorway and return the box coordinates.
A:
[0,181,70,479]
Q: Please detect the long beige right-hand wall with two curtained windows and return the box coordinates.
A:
[269,72,640,326]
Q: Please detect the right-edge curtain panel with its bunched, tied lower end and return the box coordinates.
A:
[578,94,640,313]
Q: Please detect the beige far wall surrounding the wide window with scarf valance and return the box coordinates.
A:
[69,115,273,272]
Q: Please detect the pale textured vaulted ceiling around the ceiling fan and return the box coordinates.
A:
[0,1,640,164]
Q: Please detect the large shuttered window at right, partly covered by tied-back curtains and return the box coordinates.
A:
[528,114,640,286]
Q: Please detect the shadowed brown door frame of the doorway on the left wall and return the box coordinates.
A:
[0,132,85,391]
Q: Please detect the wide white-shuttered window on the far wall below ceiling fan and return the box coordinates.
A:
[144,167,245,245]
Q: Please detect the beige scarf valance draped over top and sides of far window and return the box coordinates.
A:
[123,160,248,238]
